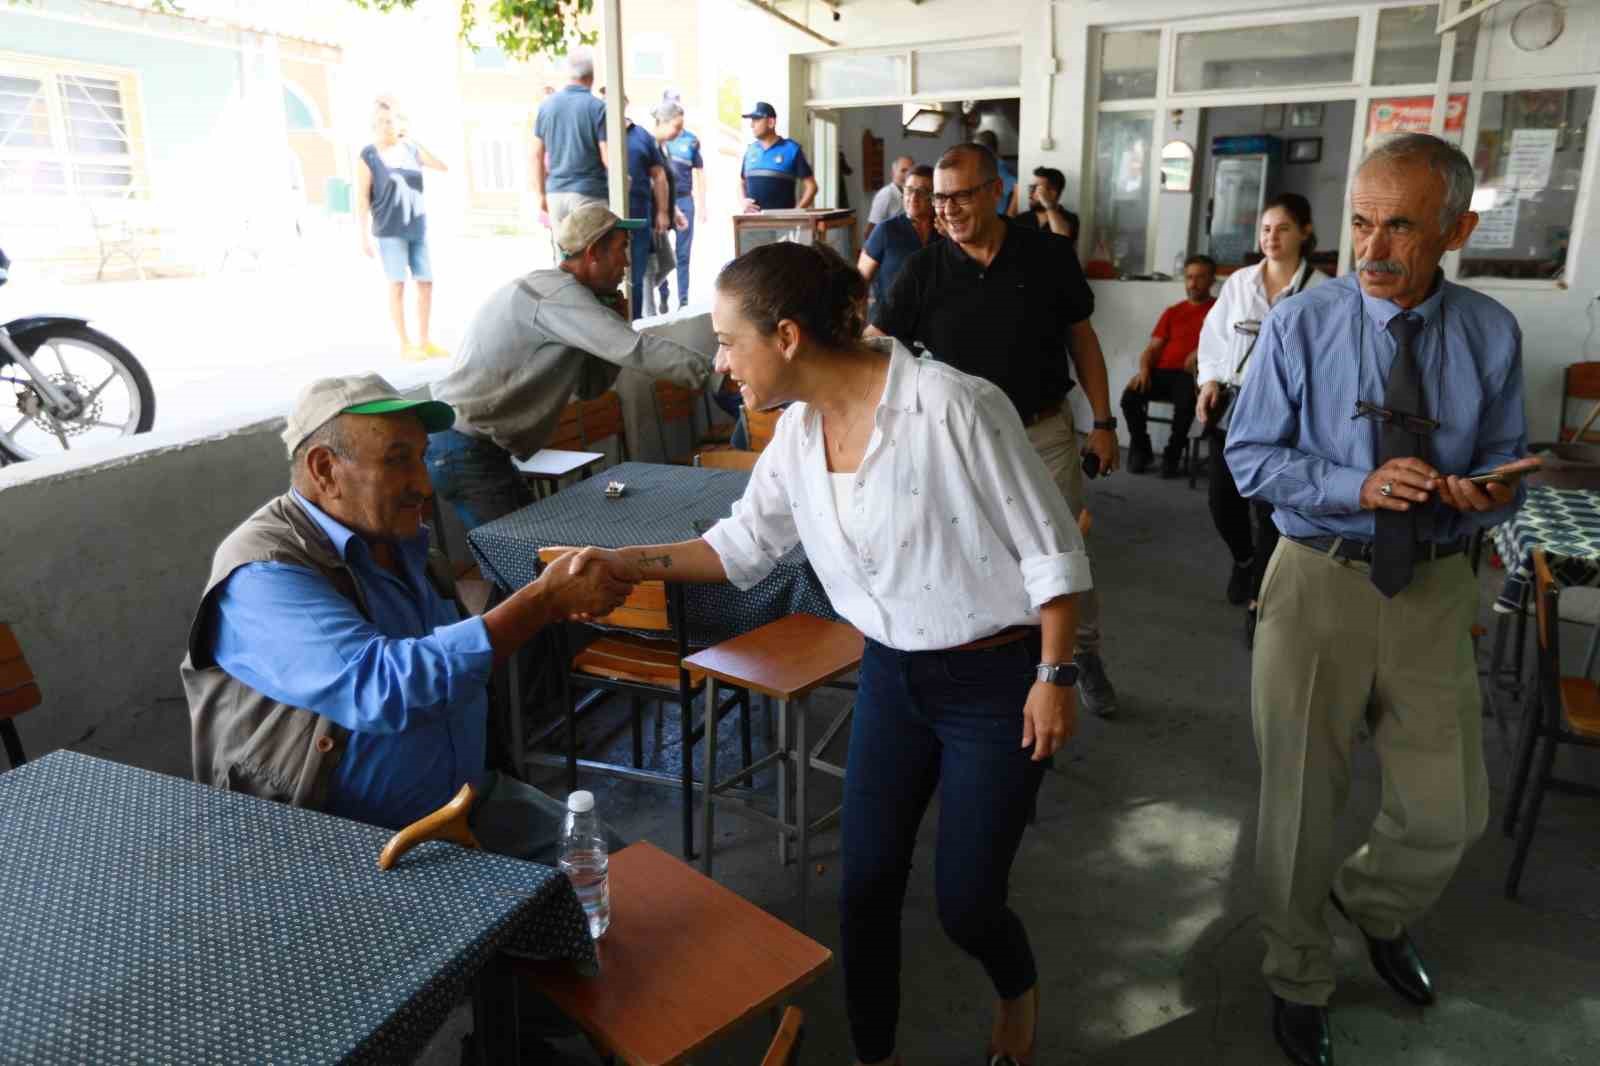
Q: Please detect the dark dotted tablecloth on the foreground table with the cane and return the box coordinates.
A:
[0,752,595,1066]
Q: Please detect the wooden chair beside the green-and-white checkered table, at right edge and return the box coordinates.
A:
[1504,549,1600,900]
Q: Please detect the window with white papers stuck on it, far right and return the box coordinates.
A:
[1461,88,1595,279]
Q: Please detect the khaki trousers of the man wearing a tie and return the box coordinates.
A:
[1251,538,1488,1004]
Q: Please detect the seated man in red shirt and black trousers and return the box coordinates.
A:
[1122,256,1216,477]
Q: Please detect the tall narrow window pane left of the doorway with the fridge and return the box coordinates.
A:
[1090,110,1155,274]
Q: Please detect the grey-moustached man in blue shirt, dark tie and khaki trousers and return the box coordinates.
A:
[1226,133,1528,1066]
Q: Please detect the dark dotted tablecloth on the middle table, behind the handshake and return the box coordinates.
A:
[467,463,838,647]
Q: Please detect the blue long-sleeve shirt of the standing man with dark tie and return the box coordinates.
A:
[1224,274,1528,541]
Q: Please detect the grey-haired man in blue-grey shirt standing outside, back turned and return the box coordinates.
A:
[528,48,610,261]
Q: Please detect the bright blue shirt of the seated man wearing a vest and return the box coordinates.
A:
[213,493,494,829]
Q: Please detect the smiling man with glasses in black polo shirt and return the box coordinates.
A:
[869,142,1117,717]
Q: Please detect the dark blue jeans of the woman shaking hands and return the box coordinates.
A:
[840,632,1043,1063]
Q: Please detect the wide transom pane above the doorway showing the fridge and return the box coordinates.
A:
[1174,18,1360,93]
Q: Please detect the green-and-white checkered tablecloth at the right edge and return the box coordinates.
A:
[1491,485,1600,613]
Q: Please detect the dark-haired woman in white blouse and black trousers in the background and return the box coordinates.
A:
[1195,192,1328,643]
